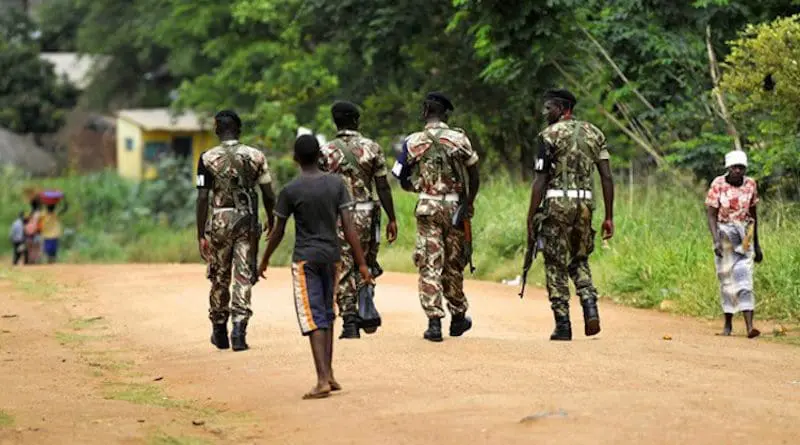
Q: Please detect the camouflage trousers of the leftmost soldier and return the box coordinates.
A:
[207,208,258,323]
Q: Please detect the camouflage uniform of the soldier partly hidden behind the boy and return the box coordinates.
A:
[320,130,388,317]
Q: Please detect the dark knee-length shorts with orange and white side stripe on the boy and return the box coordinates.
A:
[292,261,339,335]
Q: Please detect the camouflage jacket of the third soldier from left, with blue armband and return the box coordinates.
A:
[406,122,478,195]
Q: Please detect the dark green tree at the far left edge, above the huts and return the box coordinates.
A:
[0,9,77,135]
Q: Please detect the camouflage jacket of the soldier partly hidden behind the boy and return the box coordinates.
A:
[320,130,388,202]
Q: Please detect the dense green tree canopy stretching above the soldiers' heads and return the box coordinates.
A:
[20,0,800,196]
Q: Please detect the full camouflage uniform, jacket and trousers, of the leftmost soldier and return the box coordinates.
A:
[197,141,272,324]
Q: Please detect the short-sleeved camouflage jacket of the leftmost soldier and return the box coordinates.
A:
[197,140,272,209]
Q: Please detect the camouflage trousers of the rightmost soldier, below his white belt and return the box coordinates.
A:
[540,198,597,315]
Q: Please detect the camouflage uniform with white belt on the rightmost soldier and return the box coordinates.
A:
[535,119,609,317]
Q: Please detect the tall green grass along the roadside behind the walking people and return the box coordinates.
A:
[0,168,800,322]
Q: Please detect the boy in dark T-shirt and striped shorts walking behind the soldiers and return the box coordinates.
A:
[259,135,372,399]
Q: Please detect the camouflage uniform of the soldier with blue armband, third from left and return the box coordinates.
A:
[406,122,478,319]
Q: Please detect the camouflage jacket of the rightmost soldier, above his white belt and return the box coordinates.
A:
[534,119,609,190]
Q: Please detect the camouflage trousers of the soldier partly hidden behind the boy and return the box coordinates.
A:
[336,207,380,317]
